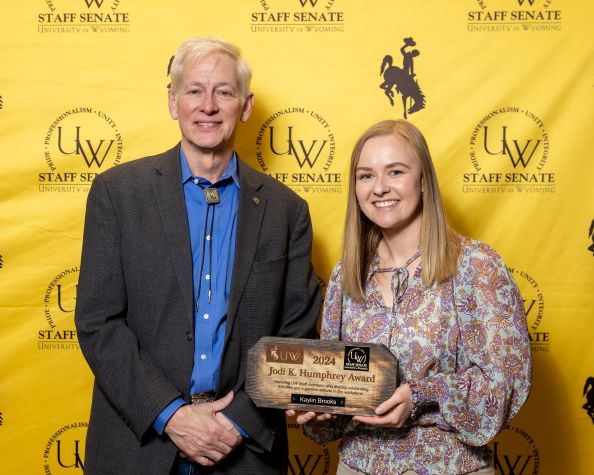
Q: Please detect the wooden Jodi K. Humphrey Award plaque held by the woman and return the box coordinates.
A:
[245,337,398,415]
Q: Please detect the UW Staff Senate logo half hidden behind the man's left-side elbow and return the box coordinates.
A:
[37,267,79,350]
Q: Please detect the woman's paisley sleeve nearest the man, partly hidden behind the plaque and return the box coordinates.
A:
[303,262,351,444]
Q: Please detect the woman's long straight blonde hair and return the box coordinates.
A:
[342,120,460,301]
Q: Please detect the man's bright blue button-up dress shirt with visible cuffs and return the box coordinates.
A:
[153,147,240,436]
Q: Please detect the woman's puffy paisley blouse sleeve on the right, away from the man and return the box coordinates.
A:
[410,243,532,446]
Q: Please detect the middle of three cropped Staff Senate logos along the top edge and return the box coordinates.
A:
[250,0,344,33]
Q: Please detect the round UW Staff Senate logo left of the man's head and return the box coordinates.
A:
[38,107,122,193]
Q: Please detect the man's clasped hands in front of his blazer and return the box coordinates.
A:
[165,392,241,466]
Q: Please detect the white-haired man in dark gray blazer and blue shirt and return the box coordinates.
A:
[76,38,320,475]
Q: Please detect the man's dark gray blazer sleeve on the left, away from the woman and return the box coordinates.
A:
[75,175,180,439]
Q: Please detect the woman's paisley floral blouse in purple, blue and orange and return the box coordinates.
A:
[304,238,531,475]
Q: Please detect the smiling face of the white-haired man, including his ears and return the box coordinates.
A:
[169,54,254,158]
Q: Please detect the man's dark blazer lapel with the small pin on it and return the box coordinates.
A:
[225,159,266,343]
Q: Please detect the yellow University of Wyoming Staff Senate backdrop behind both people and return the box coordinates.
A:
[0,0,594,475]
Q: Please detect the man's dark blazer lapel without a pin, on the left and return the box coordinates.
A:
[152,145,194,322]
